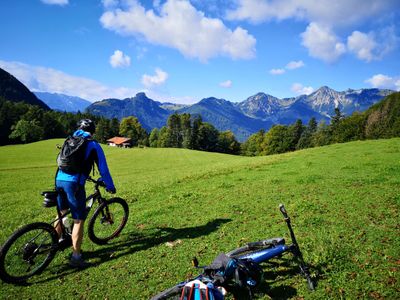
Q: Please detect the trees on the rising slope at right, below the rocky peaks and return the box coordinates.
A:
[241,93,400,156]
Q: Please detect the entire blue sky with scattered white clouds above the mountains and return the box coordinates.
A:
[0,0,400,104]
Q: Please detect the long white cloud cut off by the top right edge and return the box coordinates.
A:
[227,0,398,27]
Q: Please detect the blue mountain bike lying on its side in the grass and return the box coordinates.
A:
[152,204,314,300]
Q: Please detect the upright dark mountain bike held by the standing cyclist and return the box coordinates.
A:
[0,177,129,283]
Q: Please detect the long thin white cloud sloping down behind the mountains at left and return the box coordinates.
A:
[0,60,139,101]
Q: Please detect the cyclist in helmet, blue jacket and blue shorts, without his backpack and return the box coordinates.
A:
[56,119,116,268]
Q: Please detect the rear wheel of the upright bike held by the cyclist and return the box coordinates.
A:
[0,222,58,283]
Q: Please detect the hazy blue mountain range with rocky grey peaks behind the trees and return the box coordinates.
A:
[86,86,394,141]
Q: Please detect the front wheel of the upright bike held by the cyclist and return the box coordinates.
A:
[88,198,129,245]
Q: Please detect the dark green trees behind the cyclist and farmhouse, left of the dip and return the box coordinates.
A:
[0,98,240,154]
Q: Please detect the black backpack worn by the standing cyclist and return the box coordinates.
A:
[57,136,88,174]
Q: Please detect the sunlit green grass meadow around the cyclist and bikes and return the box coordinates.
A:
[0,139,400,299]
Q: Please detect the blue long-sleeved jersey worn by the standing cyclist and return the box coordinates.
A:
[56,129,114,190]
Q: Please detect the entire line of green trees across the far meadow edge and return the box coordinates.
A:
[0,93,400,156]
